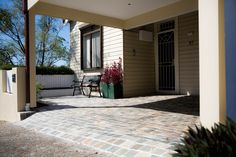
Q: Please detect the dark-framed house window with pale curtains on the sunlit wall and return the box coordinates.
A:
[81,25,102,69]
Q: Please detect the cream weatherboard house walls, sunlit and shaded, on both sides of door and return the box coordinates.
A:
[70,12,199,97]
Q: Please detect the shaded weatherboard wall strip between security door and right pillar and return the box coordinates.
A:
[178,12,199,95]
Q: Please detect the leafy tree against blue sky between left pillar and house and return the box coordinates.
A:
[36,16,69,66]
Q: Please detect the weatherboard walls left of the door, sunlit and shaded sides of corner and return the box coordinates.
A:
[70,22,155,97]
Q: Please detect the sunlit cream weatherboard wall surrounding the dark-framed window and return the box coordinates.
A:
[70,22,123,81]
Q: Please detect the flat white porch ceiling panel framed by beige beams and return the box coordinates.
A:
[40,0,180,20]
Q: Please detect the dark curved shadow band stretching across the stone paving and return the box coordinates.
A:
[35,96,199,116]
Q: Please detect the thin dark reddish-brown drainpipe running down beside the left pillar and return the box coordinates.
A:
[22,0,30,110]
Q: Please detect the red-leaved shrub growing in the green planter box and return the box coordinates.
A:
[101,59,123,84]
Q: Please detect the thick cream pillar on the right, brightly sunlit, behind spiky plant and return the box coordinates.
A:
[199,0,226,127]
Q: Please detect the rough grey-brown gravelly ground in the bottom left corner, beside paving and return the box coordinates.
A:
[0,121,111,157]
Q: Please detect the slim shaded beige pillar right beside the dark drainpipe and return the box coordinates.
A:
[29,11,36,107]
